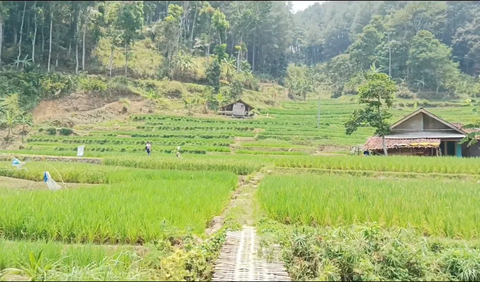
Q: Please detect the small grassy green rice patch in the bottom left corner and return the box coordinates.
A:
[0,239,152,281]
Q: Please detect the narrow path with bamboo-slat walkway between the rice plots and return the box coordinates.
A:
[207,171,290,281]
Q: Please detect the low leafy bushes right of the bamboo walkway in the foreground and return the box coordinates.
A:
[257,220,480,281]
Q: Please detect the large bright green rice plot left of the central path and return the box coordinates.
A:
[0,169,237,244]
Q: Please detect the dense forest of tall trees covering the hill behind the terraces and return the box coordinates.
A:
[0,1,480,107]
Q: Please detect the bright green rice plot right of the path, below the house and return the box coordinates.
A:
[259,175,480,238]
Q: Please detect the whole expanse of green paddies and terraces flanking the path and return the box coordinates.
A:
[0,99,480,281]
